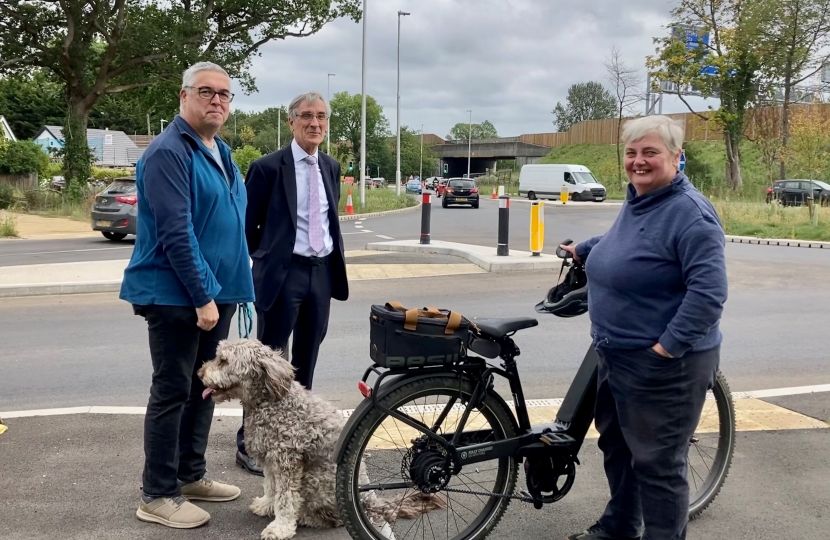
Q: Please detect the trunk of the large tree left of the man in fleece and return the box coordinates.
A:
[63,96,93,199]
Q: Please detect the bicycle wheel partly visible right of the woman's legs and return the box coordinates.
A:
[686,371,735,519]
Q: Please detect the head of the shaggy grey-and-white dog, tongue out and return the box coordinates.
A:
[197,339,294,402]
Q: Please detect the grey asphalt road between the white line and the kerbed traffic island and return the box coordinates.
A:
[0,251,830,411]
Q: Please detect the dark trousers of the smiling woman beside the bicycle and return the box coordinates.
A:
[596,347,720,540]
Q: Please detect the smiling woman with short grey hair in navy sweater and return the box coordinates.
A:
[562,116,727,540]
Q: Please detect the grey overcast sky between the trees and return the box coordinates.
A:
[234,0,720,137]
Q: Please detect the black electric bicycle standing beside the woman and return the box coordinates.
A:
[335,251,735,540]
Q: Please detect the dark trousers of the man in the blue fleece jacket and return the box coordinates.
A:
[136,304,236,497]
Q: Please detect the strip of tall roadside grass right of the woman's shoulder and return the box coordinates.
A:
[712,201,830,242]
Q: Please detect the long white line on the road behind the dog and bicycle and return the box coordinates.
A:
[0,384,830,419]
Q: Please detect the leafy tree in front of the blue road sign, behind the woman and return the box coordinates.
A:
[648,0,771,189]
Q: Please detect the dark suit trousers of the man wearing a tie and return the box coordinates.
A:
[236,256,331,454]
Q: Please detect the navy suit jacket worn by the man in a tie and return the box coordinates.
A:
[245,145,349,311]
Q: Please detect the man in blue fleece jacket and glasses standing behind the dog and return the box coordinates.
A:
[121,62,254,529]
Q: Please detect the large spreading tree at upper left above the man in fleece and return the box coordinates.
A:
[0,0,361,198]
